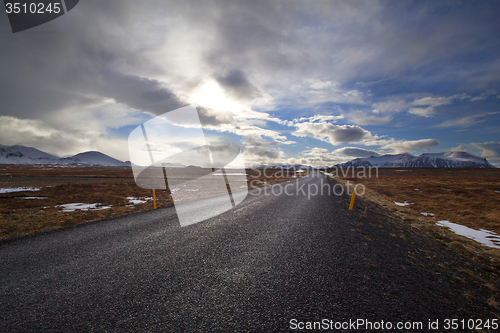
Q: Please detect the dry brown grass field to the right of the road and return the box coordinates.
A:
[329,168,500,263]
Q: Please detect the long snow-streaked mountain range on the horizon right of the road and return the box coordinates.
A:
[337,151,495,168]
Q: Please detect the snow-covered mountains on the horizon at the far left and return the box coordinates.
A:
[0,145,130,166]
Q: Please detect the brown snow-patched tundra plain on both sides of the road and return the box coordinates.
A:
[0,165,500,263]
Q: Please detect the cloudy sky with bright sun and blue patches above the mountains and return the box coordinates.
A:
[0,0,500,166]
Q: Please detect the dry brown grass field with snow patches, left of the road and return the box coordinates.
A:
[0,165,301,239]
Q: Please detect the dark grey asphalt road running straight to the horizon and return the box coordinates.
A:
[0,170,496,332]
